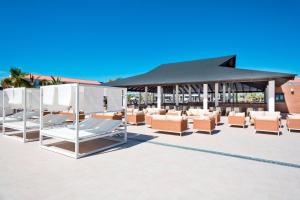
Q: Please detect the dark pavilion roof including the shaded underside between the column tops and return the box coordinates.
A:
[105,55,295,93]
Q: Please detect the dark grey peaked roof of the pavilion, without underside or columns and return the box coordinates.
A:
[106,55,295,86]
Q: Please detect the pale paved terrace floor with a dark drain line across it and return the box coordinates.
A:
[0,118,300,200]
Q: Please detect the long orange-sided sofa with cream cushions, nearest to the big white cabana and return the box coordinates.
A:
[151,115,188,136]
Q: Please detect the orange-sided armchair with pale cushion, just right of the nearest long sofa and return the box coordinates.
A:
[193,115,216,134]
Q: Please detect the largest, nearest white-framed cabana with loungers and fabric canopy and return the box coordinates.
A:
[40,84,127,158]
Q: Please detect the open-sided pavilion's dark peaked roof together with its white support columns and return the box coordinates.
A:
[106,55,295,110]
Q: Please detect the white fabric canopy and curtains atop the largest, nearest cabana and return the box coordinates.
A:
[41,84,126,113]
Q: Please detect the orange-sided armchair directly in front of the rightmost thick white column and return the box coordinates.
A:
[254,116,280,136]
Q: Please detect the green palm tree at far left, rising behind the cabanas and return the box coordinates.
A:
[1,68,32,88]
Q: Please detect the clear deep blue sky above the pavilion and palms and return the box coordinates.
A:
[0,0,300,81]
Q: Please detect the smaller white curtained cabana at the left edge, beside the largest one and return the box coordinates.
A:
[2,87,40,142]
